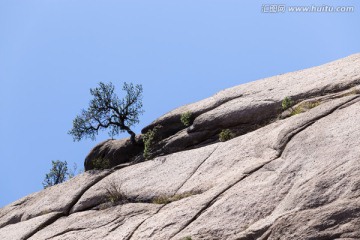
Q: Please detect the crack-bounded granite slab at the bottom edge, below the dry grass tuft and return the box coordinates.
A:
[29,203,160,240]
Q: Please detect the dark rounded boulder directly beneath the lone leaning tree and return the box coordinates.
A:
[84,138,144,171]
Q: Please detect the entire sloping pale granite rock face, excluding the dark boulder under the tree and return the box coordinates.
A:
[0,54,360,240]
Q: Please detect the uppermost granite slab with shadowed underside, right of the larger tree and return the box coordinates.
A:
[142,54,360,158]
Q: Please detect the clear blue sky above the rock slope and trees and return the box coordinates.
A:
[0,0,360,207]
